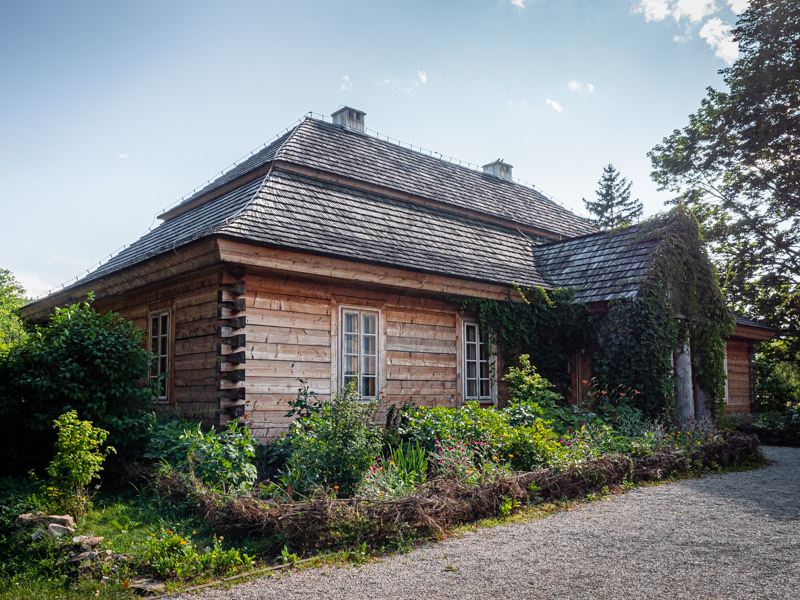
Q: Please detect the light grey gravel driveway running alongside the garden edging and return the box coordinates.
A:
[182,447,800,600]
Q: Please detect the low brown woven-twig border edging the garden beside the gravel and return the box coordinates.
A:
[158,434,763,553]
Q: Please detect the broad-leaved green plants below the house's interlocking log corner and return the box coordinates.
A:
[145,420,257,494]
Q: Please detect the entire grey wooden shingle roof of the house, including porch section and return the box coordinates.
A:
[32,114,649,302]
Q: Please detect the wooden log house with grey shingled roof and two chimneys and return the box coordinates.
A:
[22,107,766,439]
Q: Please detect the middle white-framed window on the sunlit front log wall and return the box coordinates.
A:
[339,308,379,398]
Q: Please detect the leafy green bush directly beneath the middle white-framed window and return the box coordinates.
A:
[281,383,381,496]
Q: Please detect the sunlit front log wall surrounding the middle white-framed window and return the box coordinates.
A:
[244,273,461,439]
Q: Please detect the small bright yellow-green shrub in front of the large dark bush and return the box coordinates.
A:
[47,410,116,519]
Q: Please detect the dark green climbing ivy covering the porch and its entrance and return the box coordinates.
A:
[461,206,734,417]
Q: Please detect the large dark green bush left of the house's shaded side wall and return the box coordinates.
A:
[0,297,153,470]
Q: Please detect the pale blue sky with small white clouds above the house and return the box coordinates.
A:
[0,0,747,297]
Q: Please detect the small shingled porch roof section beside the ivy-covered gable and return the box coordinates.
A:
[533,226,655,302]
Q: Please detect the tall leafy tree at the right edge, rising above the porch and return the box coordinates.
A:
[649,0,800,362]
